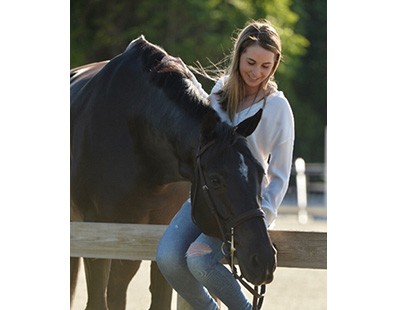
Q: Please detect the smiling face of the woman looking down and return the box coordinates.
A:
[239,44,276,93]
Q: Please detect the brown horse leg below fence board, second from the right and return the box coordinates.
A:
[107,259,141,310]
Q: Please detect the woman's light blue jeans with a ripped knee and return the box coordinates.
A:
[156,199,252,310]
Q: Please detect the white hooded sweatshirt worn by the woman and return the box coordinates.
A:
[193,77,295,226]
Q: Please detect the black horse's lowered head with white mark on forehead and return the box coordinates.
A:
[192,111,276,285]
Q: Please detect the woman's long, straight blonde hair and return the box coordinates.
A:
[219,20,281,120]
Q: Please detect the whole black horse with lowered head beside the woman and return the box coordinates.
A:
[70,36,276,310]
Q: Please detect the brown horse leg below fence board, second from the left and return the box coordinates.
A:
[84,258,111,310]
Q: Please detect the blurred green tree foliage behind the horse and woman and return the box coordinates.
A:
[70,0,326,161]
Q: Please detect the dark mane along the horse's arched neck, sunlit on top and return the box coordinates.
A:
[126,35,216,120]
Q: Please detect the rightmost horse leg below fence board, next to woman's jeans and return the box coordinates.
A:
[149,262,172,310]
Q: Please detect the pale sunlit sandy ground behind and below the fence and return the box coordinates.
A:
[71,215,327,310]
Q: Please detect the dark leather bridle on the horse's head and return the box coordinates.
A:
[192,137,266,310]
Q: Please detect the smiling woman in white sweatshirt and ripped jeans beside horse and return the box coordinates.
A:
[156,20,294,310]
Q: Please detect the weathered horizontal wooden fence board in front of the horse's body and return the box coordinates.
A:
[70,222,327,269]
